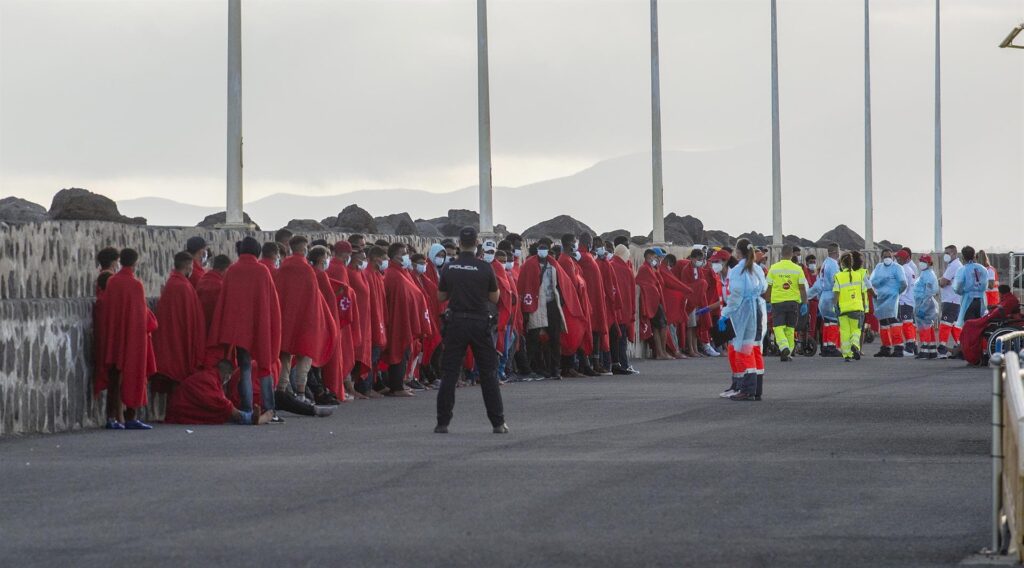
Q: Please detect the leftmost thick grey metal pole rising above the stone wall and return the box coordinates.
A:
[224,0,243,226]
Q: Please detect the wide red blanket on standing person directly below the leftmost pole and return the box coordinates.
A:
[207,255,281,377]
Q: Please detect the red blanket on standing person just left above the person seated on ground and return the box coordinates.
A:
[153,271,206,386]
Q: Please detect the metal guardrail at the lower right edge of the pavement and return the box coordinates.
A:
[988,332,1024,562]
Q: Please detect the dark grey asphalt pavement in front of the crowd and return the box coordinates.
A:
[0,358,990,567]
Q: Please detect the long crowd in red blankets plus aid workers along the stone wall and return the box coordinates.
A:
[94,229,1020,432]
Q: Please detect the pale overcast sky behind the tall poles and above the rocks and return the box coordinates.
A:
[0,0,1024,250]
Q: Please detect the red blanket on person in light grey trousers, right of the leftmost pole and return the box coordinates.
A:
[273,255,338,366]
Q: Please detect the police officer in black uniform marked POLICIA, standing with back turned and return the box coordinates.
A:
[434,227,509,434]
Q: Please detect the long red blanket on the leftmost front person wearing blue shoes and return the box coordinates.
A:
[100,266,157,408]
